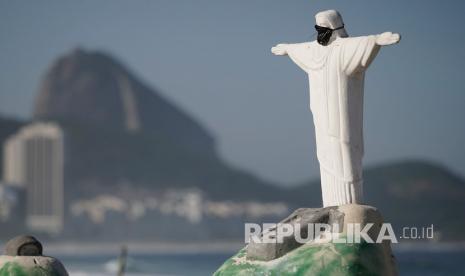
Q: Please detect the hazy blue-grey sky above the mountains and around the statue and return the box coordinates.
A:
[0,0,465,183]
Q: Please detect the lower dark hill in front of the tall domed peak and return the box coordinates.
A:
[60,118,281,200]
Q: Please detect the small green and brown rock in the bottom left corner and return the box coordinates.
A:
[0,235,68,276]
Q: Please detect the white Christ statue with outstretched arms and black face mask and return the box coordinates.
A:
[271,10,400,207]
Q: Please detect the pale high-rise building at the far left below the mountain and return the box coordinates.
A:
[3,122,64,233]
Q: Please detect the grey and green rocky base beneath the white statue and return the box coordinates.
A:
[215,204,397,276]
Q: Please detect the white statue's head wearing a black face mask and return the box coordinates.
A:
[315,10,348,46]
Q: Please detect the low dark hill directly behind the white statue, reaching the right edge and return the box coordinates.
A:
[291,160,465,240]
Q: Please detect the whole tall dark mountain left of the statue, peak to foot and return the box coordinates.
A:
[29,49,280,200]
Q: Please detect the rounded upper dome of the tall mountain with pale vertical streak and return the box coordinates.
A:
[34,49,214,153]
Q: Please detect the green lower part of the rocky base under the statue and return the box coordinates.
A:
[214,240,393,276]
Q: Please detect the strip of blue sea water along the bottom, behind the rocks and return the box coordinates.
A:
[56,249,465,276]
